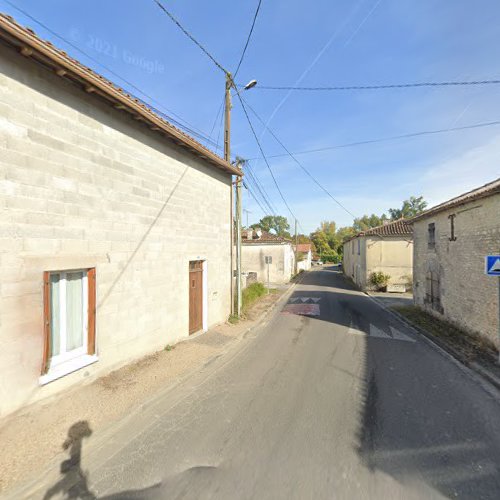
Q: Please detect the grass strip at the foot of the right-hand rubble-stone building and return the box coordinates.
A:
[392,306,498,363]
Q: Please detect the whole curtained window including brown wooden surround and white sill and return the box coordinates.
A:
[42,269,95,373]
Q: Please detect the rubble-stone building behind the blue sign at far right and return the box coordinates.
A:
[413,179,500,343]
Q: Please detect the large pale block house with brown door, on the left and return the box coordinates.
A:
[0,15,240,416]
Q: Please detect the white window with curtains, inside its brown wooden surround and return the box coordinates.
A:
[49,270,88,366]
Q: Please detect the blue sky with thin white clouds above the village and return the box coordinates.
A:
[0,0,500,233]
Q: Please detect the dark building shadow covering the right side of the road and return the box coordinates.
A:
[292,267,500,500]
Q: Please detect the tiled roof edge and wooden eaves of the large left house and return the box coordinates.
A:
[0,14,242,175]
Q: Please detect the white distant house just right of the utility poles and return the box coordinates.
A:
[241,229,295,285]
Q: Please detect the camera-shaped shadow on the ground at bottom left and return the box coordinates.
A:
[43,420,163,500]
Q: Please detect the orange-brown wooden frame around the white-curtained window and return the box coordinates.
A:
[41,268,96,375]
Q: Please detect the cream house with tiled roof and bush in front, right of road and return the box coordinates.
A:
[343,219,413,290]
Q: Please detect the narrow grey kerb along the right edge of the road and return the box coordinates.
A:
[364,292,500,390]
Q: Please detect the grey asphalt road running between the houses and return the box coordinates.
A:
[37,268,500,500]
